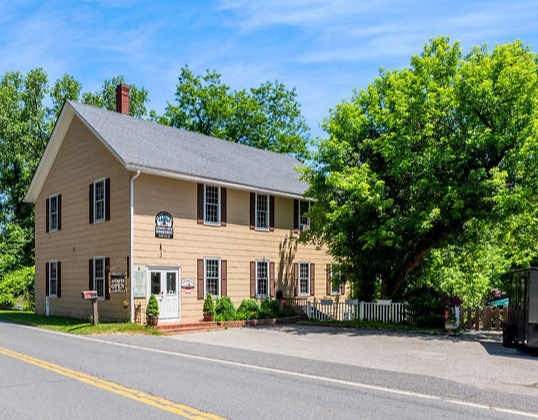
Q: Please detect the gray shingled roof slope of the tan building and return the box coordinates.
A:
[68,101,308,195]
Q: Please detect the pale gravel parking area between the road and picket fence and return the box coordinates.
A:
[173,325,538,396]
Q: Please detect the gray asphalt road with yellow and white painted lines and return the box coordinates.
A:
[0,323,538,420]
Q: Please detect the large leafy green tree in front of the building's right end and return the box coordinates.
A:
[305,37,538,298]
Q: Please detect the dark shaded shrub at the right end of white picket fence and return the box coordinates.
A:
[405,286,445,328]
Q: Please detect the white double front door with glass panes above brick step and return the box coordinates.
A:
[149,268,180,319]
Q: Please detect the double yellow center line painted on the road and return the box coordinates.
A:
[0,347,226,420]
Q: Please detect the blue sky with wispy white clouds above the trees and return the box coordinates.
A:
[0,0,538,135]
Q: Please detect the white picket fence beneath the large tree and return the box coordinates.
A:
[306,300,411,323]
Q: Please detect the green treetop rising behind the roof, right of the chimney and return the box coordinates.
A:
[151,67,310,160]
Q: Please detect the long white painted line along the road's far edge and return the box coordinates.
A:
[6,324,538,419]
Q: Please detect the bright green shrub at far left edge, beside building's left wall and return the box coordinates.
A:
[0,266,35,310]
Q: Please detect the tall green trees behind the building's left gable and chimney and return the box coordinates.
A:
[0,68,147,279]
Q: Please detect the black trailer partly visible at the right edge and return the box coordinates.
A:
[503,267,538,347]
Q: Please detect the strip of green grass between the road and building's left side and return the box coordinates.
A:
[0,310,161,335]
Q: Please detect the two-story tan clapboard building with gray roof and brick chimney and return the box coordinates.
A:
[26,85,344,322]
